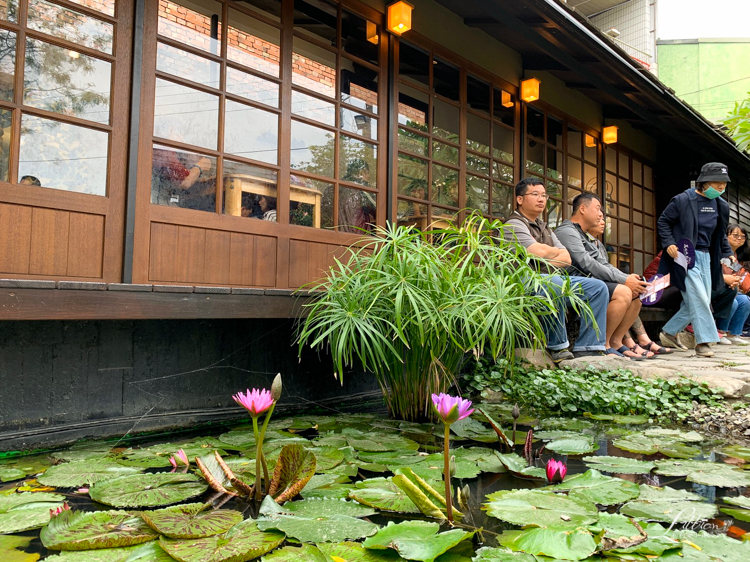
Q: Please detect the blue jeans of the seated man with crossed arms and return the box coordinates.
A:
[542,275,609,351]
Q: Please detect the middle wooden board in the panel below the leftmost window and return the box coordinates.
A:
[29,208,70,276]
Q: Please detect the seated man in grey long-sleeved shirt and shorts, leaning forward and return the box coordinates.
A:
[555,192,648,359]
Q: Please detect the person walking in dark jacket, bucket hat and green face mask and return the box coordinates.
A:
[657,162,735,357]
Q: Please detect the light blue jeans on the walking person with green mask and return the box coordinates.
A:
[662,251,719,343]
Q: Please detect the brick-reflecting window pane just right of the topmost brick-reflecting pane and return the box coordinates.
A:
[227,10,281,76]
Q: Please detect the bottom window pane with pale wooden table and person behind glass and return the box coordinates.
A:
[222,160,278,219]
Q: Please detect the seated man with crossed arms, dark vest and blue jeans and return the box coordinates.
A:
[503,178,609,362]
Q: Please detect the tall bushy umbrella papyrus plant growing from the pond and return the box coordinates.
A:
[297,215,592,421]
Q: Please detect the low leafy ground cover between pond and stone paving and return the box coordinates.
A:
[468,357,722,421]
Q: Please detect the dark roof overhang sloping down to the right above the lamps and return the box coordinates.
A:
[437,0,750,176]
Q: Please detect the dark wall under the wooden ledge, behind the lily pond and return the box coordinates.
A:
[0,319,377,450]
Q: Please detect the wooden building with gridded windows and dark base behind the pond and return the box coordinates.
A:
[0,0,750,446]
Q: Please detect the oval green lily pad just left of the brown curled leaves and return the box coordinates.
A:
[89,472,208,507]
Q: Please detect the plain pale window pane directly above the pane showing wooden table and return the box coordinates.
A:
[224,100,279,164]
